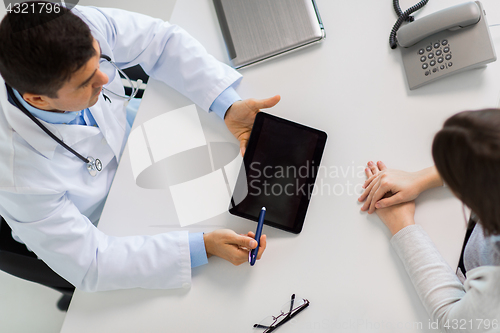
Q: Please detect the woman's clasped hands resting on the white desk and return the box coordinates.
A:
[358,161,443,214]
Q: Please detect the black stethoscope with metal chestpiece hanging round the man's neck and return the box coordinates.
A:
[5,54,142,177]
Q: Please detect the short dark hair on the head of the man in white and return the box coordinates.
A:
[0,1,96,98]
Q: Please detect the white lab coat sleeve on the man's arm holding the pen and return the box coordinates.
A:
[0,191,191,292]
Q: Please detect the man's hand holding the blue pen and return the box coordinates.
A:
[203,229,267,266]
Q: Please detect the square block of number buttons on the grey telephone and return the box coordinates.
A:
[417,39,453,76]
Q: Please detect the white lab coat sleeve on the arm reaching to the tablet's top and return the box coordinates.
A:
[73,6,241,111]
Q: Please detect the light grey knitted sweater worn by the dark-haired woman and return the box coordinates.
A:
[391,225,500,333]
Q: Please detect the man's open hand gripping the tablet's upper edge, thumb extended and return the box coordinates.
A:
[224,95,281,156]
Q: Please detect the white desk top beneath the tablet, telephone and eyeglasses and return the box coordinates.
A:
[62,0,500,333]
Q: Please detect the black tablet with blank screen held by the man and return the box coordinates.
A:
[229,112,327,234]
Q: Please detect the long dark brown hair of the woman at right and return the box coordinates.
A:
[432,109,500,235]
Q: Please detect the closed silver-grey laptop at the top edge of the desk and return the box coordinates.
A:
[213,0,325,68]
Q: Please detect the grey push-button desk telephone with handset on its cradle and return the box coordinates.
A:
[397,1,496,90]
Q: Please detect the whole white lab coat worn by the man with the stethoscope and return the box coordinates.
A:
[0,6,241,291]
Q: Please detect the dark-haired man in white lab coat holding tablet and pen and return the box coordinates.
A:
[0,2,279,292]
